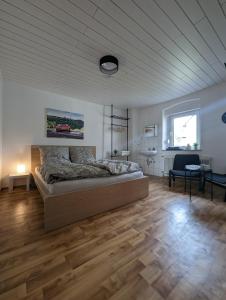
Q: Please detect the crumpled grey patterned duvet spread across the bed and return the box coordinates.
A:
[39,158,140,183]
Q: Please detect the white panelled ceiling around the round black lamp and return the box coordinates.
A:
[0,0,226,107]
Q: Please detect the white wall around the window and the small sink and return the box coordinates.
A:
[132,82,226,175]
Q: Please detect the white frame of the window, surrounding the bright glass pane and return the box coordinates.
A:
[167,108,201,150]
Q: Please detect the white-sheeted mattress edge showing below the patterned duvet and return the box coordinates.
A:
[35,168,144,195]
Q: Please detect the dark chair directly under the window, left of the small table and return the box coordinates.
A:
[169,154,201,191]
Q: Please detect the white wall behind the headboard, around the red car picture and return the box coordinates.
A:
[3,81,103,185]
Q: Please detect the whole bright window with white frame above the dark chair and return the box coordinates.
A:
[167,110,200,148]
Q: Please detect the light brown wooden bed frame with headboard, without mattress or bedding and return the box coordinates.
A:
[31,145,149,230]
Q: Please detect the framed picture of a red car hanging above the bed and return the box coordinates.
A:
[46,108,84,140]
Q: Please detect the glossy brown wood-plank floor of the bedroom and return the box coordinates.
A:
[0,178,226,300]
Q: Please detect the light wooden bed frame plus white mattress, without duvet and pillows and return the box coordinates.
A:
[31,145,149,230]
